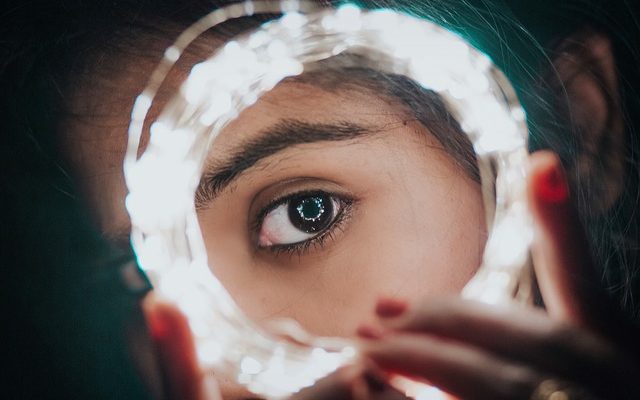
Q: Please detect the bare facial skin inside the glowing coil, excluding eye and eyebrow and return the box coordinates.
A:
[199,82,485,335]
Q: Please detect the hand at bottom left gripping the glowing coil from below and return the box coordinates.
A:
[143,294,406,400]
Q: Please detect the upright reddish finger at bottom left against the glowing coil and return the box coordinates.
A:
[143,295,204,400]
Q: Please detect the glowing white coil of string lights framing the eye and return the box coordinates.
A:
[124,1,532,399]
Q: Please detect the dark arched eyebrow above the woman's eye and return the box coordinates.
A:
[195,119,380,208]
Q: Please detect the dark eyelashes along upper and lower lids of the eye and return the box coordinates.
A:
[252,190,355,257]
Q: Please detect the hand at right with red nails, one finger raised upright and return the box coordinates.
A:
[359,152,640,400]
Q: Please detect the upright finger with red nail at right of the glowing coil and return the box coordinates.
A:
[528,151,612,331]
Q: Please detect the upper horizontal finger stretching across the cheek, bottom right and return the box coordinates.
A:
[370,298,640,391]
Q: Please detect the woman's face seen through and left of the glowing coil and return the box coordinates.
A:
[62,28,486,335]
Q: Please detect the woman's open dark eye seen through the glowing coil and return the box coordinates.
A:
[255,191,353,254]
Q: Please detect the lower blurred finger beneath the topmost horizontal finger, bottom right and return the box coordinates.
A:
[362,333,542,400]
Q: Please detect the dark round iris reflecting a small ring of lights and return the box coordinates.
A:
[289,195,333,233]
